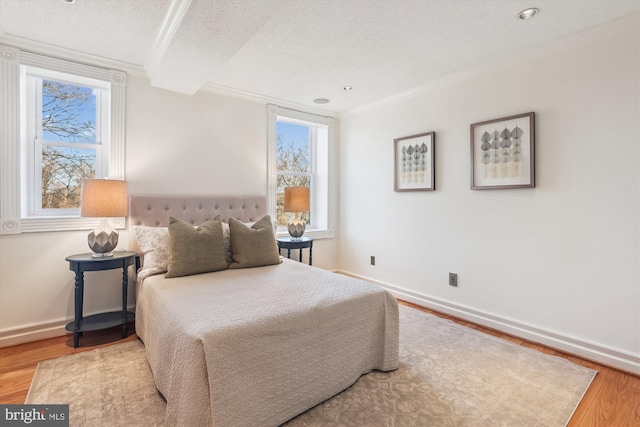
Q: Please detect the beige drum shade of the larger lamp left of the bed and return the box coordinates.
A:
[80,179,128,218]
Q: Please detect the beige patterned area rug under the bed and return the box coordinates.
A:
[26,306,596,427]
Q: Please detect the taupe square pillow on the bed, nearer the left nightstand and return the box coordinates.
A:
[165,216,229,277]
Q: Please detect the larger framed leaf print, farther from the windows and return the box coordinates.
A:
[471,112,535,190]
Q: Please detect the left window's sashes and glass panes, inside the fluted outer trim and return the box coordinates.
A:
[22,67,110,217]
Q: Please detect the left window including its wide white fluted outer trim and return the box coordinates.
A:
[0,45,126,234]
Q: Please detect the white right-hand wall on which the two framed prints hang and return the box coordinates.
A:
[339,16,640,372]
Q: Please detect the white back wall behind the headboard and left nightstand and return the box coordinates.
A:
[0,76,337,345]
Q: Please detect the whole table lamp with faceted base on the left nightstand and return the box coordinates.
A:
[80,179,128,258]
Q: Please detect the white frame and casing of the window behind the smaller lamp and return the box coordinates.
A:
[267,104,335,238]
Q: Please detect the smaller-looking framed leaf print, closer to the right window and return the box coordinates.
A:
[393,132,436,191]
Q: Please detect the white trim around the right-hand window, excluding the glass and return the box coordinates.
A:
[267,104,336,239]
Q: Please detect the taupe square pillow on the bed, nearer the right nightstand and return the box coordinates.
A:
[229,215,281,268]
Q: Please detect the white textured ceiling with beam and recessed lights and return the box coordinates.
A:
[0,0,640,113]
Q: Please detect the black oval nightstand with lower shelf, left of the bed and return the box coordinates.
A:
[66,251,137,347]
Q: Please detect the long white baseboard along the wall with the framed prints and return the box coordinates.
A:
[338,271,640,375]
